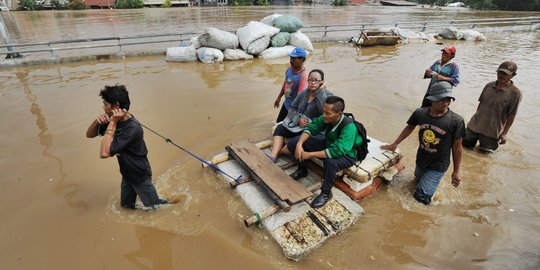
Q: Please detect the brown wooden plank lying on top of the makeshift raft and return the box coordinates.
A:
[225,141,313,211]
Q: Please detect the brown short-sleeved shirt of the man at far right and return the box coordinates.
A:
[467,81,521,139]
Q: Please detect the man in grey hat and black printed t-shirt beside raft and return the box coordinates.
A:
[381,82,465,205]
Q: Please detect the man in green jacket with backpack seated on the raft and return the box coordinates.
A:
[287,96,362,208]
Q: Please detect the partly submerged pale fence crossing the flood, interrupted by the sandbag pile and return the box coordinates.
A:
[0,16,540,65]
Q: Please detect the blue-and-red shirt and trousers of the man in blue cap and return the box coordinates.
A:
[276,66,308,122]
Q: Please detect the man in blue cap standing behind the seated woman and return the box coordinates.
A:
[274,48,308,123]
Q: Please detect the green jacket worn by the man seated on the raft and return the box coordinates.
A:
[304,115,362,158]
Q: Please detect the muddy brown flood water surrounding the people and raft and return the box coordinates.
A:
[0,6,540,269]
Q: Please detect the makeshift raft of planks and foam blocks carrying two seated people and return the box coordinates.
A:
[205,138,403,261]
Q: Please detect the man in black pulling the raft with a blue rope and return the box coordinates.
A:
[86,85,167,209]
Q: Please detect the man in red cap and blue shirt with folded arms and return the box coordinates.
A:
[422,47,460,107]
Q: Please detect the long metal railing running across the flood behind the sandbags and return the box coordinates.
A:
[0,16,540,58]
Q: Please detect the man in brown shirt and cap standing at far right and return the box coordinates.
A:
[463,61,521,152]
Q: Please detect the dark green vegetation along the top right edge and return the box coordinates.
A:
[415,0,540,11]
